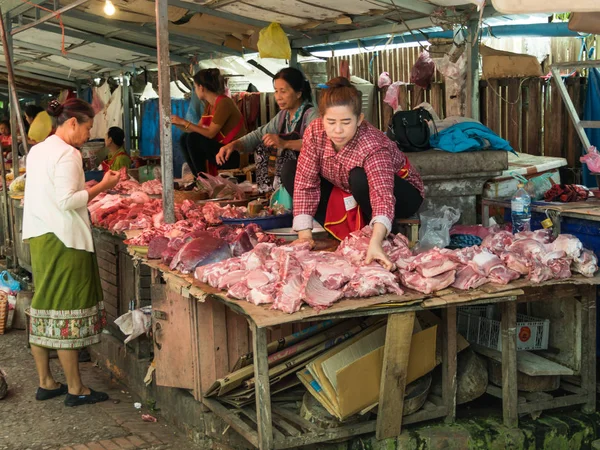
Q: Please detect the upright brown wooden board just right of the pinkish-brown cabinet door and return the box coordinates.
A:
[199,297,229,393]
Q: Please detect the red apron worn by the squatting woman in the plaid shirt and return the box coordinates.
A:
[323,159,410,241]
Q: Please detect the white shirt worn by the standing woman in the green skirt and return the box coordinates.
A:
[23,135,94,252]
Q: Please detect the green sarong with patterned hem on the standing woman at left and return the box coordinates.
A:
[29,233,106,350]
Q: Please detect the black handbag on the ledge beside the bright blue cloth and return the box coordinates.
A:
[387,107,434,152]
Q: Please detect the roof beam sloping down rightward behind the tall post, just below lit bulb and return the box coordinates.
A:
[63,10,242,56]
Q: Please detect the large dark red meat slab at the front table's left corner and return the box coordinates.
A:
[169,231,231,273]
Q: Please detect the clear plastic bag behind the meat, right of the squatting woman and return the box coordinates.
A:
[416,206,460,253]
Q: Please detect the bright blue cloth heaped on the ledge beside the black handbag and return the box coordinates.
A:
[429,122,514,153]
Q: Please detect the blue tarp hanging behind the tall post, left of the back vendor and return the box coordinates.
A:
[140,99,190,178]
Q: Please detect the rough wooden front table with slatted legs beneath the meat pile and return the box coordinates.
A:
[146,261,600,449]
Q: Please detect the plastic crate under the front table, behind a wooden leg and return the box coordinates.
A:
[458,306,550,351]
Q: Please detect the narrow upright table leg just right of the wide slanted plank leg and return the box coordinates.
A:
[442,306,457,422]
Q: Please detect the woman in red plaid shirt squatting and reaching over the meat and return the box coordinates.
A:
[282,77,424,269]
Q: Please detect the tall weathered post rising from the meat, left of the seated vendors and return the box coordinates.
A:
[155,0,175,223]
